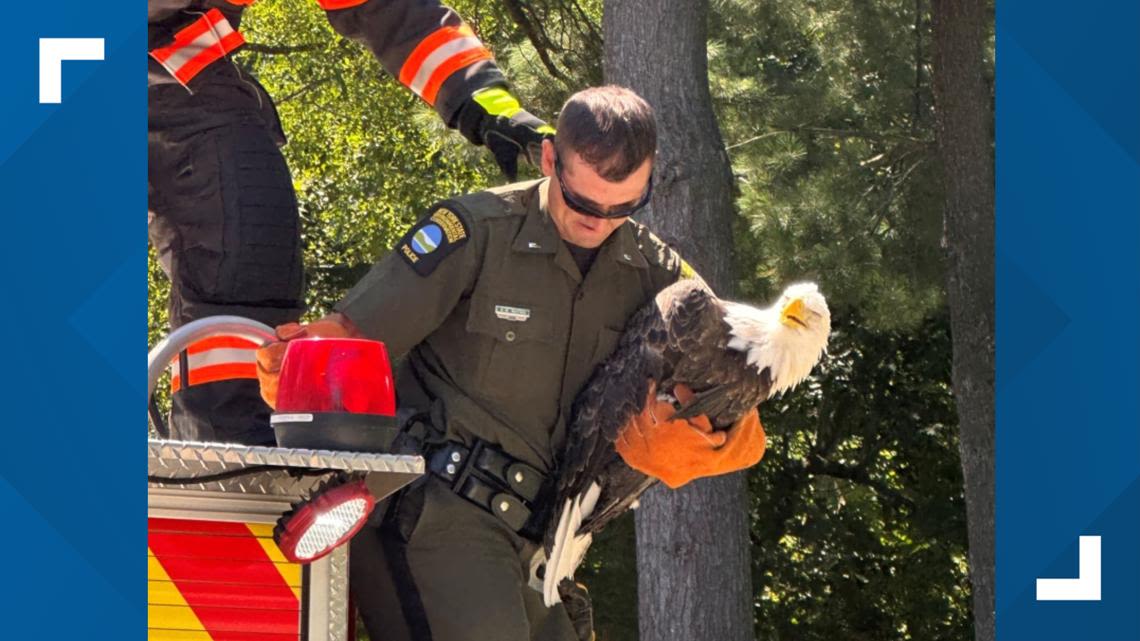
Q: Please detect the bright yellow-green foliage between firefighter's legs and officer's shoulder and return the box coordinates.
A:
[243,0,492,315]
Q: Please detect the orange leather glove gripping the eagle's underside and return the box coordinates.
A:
[614,384,766,489]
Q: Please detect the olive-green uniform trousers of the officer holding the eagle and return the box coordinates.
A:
[349,478,589,641]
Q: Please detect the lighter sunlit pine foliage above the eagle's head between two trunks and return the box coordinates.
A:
[709,0,944,330]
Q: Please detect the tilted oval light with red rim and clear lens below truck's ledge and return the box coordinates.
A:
[274,477,376,563]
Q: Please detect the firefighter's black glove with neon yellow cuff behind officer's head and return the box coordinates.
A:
[456,87,554,180]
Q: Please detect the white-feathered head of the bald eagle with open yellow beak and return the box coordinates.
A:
[724,283,831,396]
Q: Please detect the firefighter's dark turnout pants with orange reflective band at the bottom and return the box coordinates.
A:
[147,65,303,445]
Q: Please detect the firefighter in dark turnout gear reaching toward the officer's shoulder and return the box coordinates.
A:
[147,0,553,445]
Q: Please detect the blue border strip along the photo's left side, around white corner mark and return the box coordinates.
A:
[0,0,146,640]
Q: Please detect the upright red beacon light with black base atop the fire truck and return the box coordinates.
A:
[270,338,397,452]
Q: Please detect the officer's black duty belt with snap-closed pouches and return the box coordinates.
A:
[426,439,546,541]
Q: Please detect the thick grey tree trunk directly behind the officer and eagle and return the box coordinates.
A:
[603,0,754,641]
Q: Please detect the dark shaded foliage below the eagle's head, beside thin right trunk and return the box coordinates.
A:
[750,316,972,641]
